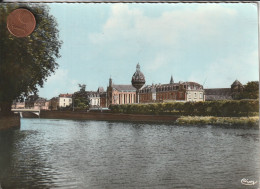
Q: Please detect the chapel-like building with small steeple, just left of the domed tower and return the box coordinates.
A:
[107,78,136,106]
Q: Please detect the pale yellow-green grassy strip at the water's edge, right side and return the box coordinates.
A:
[176,116,259,127]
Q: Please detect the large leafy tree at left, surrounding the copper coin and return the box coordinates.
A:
[0,4,62,114]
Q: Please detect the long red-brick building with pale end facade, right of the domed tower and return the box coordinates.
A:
[140,76,204,103]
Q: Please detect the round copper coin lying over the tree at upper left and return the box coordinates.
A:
[7,8,36,37]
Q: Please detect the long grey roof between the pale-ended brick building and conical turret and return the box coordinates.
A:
[204,88,232,101]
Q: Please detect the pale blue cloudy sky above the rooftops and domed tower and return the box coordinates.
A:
[39,3,259,99]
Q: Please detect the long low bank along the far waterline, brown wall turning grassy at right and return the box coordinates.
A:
[24,111,259,128]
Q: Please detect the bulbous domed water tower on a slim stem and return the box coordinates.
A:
[132,63,145,103]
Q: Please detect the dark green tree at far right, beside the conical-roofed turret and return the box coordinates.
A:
[239,81,259,99]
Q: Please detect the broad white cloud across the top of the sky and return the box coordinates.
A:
[89,4,237,46]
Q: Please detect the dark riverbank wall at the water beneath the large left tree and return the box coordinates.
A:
[0,115,20,130]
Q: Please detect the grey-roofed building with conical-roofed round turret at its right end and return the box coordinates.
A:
[205,80,244,101]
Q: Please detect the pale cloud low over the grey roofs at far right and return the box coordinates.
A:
[189,51,259,88]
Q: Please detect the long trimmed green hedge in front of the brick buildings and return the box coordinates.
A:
[110,100,259,117]
